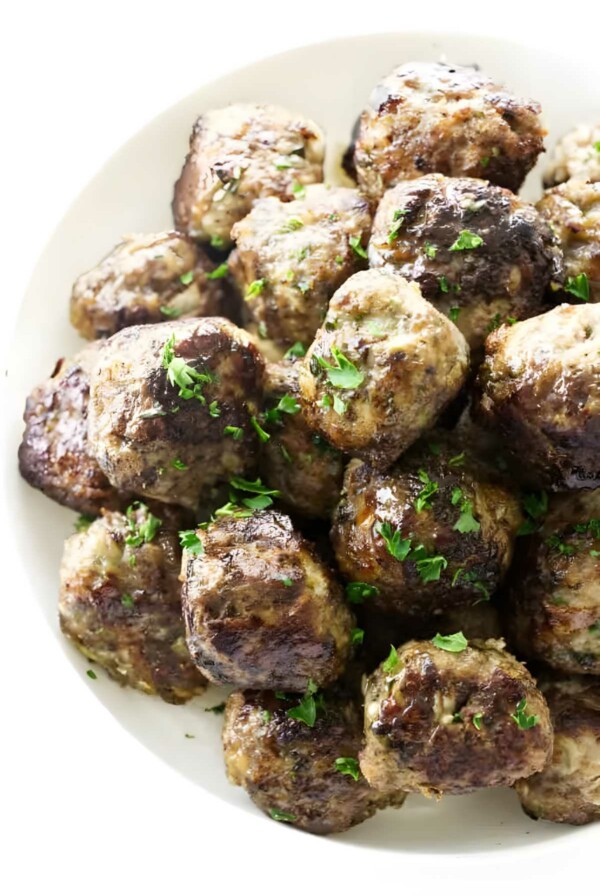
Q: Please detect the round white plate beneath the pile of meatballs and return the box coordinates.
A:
[5,34,600,858]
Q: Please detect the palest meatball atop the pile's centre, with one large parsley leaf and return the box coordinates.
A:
[299,271,469,467]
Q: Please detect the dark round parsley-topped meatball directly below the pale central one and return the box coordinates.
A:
[331,443,521,625]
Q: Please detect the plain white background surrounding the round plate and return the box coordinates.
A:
[0,0,600,896]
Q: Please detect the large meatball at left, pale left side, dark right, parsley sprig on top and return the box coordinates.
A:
[89,317,264,509]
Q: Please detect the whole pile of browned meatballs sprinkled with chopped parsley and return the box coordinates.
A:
[19,63,600,834]
